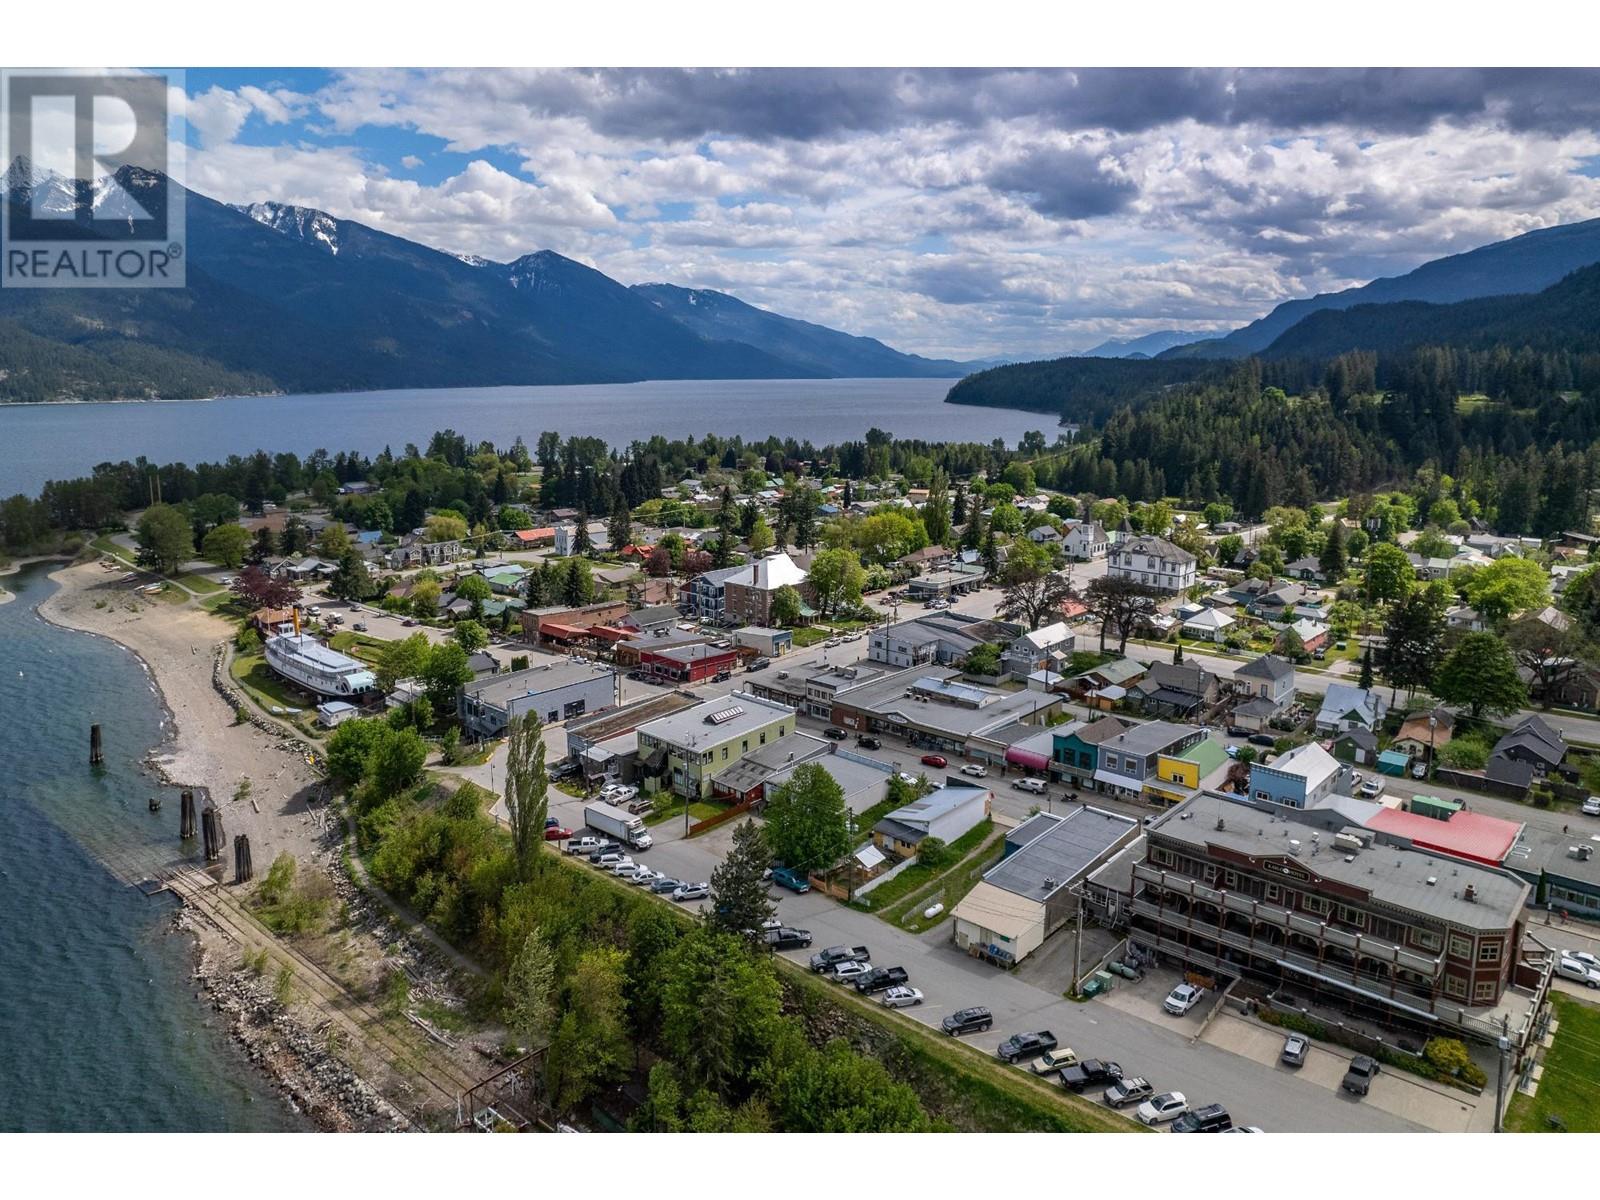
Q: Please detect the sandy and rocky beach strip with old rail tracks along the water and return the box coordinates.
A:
[40,562,501,1130]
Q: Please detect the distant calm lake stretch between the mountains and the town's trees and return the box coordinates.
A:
[0,379,1054,496]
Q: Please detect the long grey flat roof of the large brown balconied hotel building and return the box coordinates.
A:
[1147,792,1530,930]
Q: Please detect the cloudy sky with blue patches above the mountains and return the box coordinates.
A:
[187,69,1600,357]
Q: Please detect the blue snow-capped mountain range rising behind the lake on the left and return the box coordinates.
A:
[0,160,973,400]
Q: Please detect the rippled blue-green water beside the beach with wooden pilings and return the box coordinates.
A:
[0,566,309,1133]
